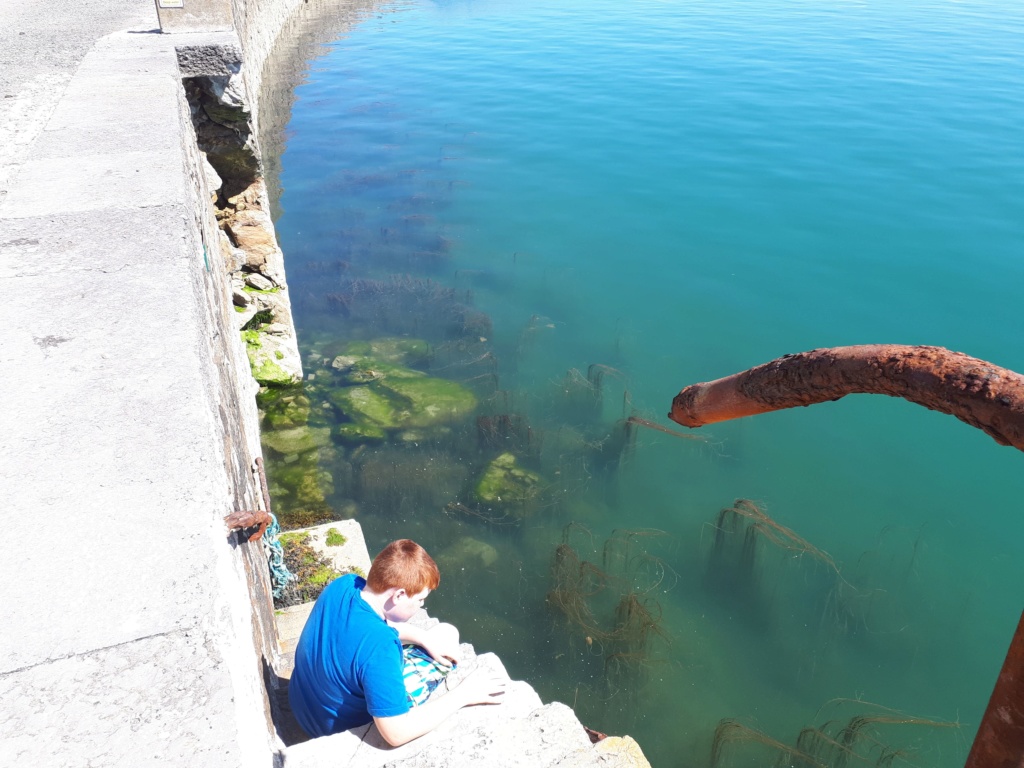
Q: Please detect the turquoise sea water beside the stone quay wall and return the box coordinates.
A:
[271,0,1024,767]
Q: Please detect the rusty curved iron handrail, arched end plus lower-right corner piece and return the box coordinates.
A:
[669,344,1024,768]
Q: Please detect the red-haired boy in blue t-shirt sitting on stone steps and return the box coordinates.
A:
[288,539,504,746]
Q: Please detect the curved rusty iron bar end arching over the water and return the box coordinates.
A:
[669,344,1024,451]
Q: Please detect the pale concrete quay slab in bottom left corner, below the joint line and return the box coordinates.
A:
[0,630,240,768]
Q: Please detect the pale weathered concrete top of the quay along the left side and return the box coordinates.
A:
[0,0,275,766]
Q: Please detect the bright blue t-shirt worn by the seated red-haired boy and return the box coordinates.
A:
[288,573,411,736]
